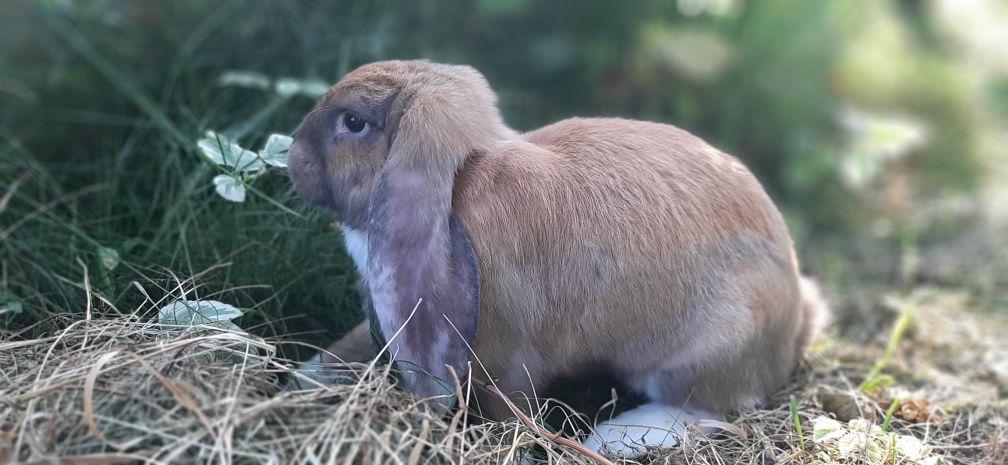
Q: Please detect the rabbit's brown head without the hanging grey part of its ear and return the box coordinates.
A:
[289,61,511,227]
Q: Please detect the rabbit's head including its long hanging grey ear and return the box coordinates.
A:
[289,62,515,401]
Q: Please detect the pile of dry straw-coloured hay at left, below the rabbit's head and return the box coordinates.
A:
[0,318,577,464]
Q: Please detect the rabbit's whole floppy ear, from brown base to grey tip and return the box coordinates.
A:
[367,91,480,395]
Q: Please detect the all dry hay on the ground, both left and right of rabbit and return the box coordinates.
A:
[0,290,1008,465]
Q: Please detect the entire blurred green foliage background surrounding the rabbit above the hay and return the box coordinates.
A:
[0,0,1008,336]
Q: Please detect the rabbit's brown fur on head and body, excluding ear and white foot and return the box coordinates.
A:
[290,62,823,417]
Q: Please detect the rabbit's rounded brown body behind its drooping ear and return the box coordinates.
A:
[454,118,798,401]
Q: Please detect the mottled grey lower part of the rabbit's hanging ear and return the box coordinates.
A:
[367,166,480,403]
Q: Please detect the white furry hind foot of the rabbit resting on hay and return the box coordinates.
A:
[584,402,717,458]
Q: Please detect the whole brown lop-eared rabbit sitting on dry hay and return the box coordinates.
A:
[288,61,827,457]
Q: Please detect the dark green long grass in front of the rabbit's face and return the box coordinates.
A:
[0,2,359,351]
